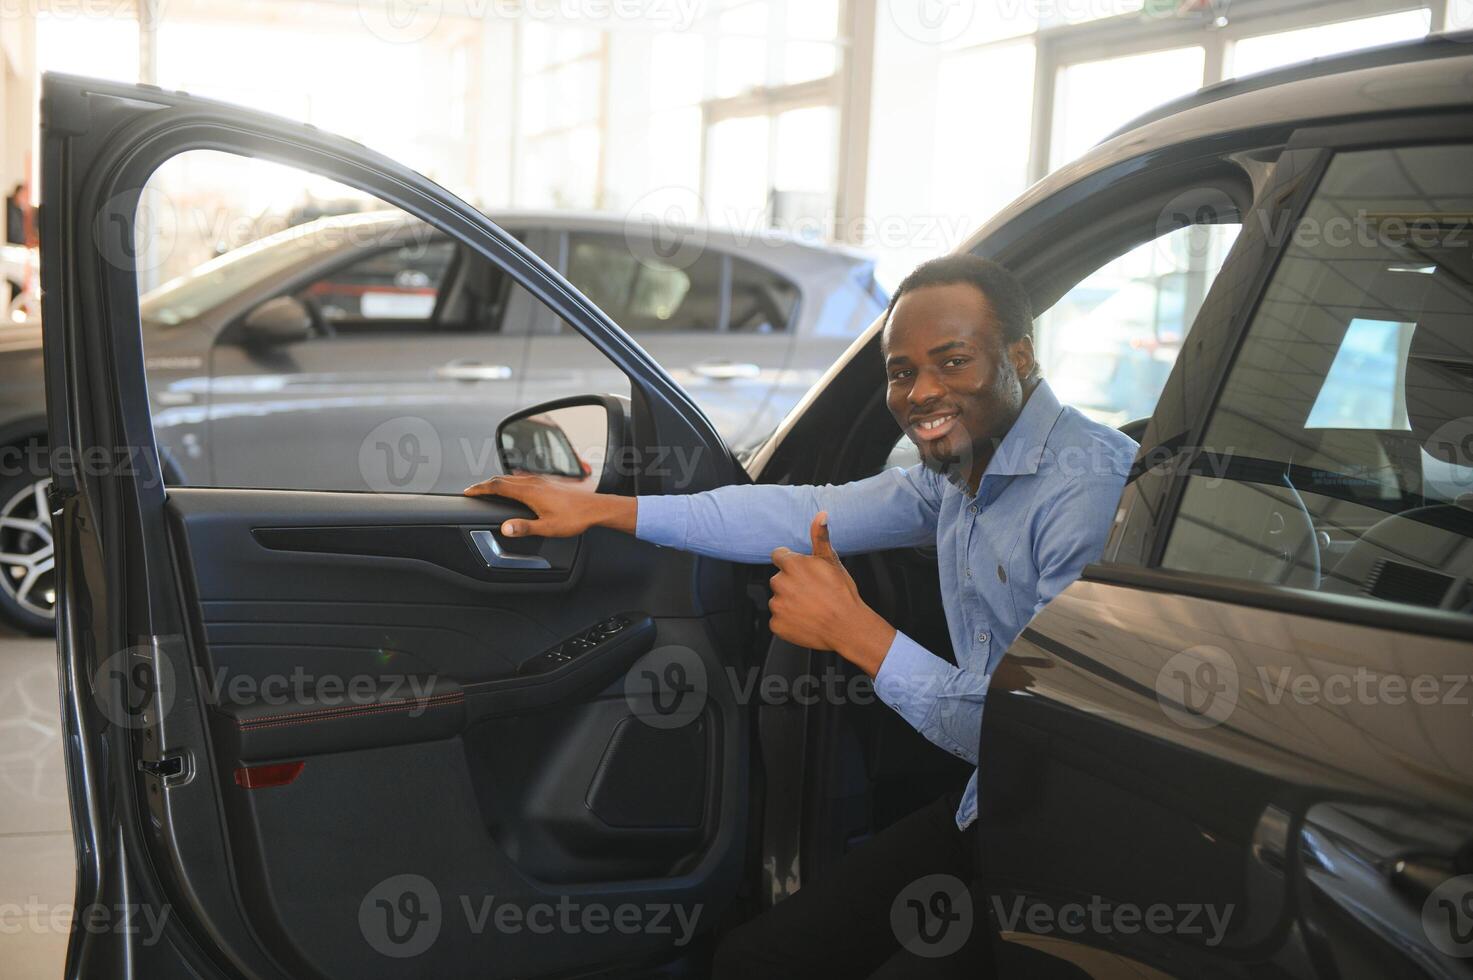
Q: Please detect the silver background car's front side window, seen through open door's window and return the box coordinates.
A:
[298,240,455,330]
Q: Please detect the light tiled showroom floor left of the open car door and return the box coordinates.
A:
[0,629,75,980]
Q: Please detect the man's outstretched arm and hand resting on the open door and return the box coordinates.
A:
[465,466,941,564]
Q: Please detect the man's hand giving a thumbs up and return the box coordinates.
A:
[767,511,896,676]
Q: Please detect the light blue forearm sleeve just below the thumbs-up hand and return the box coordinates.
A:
[875,631,991,765]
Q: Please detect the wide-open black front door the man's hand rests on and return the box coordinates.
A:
[43,75,748,977]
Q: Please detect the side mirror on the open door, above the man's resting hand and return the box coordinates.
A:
[496,395,629,494]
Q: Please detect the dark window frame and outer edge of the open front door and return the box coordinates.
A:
[41,74,742,976]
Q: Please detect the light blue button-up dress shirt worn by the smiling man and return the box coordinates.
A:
[636,382,1137,828]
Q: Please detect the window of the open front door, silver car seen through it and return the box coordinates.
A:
[138,150,630,494]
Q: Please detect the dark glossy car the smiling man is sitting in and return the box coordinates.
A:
[43,30,1473,977]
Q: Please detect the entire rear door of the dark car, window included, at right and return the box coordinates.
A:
[980,113,1473,977]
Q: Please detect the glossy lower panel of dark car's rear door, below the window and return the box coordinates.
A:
[980,569,1473,977]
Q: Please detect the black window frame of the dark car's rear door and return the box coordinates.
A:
[1101,108,1473,638]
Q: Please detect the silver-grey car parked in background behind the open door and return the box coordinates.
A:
[0,211,888,631]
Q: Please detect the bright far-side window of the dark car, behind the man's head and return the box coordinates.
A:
[887,213,1239,467]
